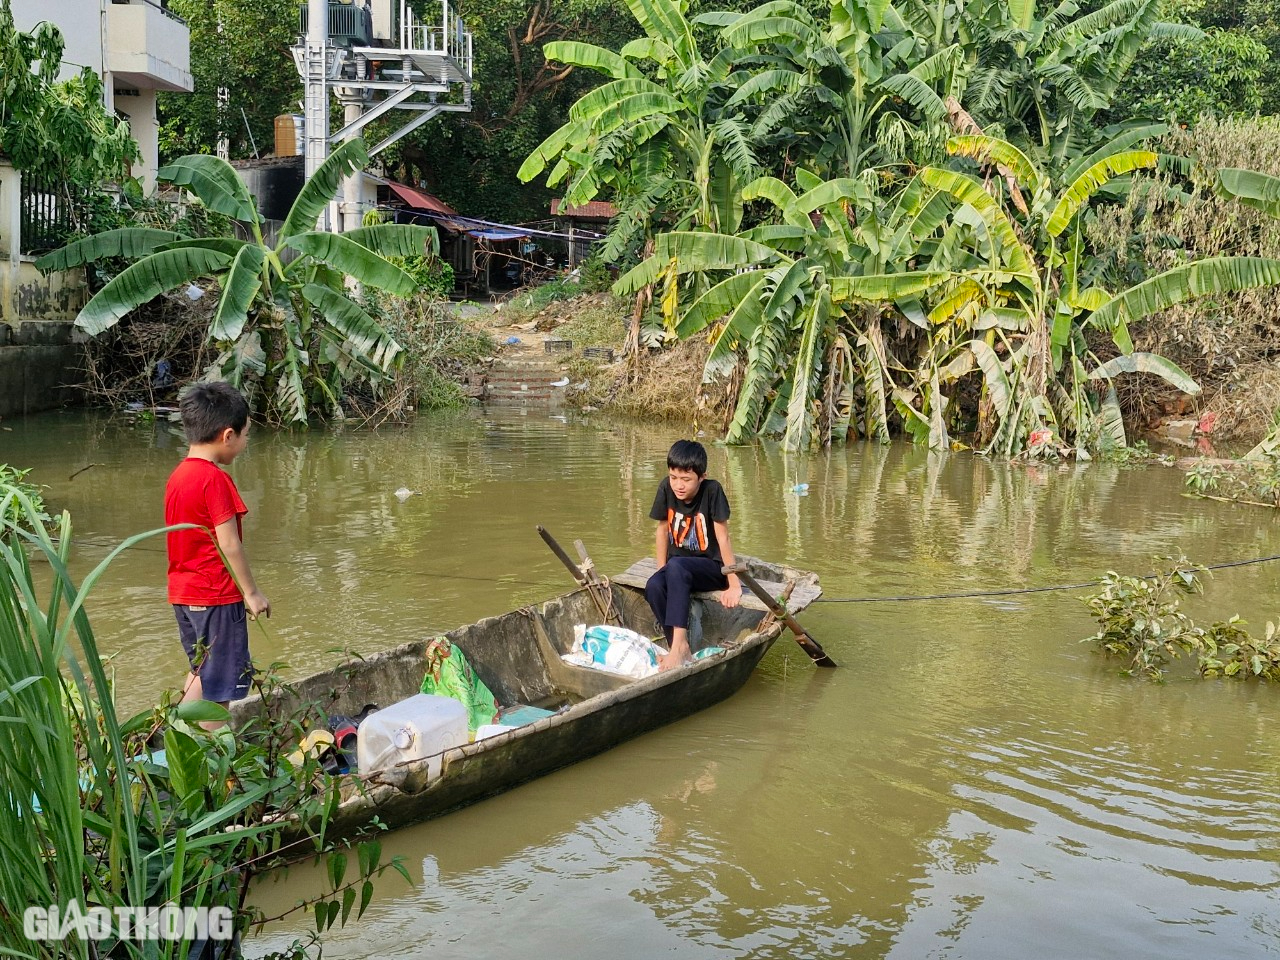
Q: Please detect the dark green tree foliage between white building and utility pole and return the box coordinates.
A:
[156,0,302,163]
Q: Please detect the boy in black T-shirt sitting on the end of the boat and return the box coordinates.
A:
[644,440,742,671]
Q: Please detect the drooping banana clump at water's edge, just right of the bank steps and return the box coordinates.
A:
[614,170,989,449]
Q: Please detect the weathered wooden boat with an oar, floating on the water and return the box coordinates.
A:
[232,558,822,855]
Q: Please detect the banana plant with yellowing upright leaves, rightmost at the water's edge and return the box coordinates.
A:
[920,136,1280,457]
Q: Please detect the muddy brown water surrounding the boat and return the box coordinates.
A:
[0,411,1280,960]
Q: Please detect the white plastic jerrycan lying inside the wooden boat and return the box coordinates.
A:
[356,694,467,780]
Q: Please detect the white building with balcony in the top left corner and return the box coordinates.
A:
[12,0,192,191]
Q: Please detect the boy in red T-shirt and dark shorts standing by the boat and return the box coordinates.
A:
[164,383,271,707]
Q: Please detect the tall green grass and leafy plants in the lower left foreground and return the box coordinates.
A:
[0,485,403,960]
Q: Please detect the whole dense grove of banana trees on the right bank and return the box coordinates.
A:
[521,0,1254,457]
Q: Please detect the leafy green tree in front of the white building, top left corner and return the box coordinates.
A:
[0,0,138,188]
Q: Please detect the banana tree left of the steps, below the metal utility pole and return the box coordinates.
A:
[36,140,436,422]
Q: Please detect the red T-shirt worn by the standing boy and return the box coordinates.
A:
[164,457,248,607]
